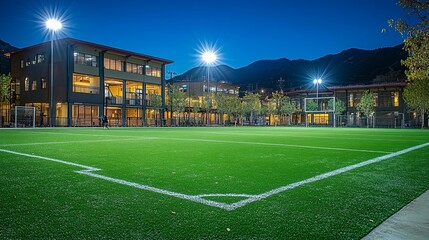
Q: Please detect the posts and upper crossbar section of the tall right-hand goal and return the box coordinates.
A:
[304,97,336,127]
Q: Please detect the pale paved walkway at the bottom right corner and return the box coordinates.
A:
[362,190,429,240]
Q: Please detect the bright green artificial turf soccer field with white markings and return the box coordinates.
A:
[0,127,429,239]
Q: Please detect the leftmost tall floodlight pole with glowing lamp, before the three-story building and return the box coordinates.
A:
[46,18,63,127]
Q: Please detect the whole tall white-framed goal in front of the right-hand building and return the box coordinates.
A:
[304,97,336,127]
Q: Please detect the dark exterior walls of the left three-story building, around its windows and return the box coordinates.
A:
[11,39,171,126]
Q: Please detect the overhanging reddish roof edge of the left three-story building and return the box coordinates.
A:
[11,38,174,64]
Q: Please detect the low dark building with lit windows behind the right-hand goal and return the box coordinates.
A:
[286,82,417,127]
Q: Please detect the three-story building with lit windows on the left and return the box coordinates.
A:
[11,38,172,126]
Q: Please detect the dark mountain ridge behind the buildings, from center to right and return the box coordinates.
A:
[174,45,407,91]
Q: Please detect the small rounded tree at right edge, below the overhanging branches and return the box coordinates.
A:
[404,79,429,128]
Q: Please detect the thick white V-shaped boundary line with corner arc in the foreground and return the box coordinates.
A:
[0,142,429,211]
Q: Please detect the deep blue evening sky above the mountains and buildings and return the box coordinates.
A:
[0,0,406,73]
